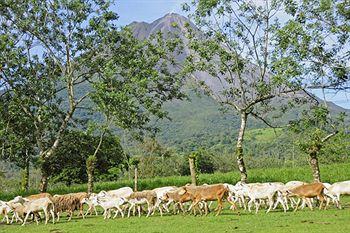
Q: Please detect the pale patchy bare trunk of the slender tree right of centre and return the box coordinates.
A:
[236,112,248,183]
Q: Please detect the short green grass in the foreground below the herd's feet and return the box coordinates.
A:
[0,198,350,233]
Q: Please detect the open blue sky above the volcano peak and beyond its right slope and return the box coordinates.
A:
[112,0,350,109]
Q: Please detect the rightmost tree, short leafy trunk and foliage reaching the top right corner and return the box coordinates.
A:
[276,0,350,181]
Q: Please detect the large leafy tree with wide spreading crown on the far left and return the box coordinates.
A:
[0,0,186,192]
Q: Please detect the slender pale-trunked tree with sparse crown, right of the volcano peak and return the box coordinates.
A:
[184,0,301,182]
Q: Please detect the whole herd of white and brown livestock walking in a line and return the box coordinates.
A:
[0,178,350,225]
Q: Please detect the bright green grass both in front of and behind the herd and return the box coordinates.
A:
[0,163,350,233]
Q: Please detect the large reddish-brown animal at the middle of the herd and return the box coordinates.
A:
[179,184,228,216]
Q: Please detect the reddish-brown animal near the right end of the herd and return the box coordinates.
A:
[287,183,326,211]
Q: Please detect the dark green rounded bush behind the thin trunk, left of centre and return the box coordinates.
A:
[49,131,125,185]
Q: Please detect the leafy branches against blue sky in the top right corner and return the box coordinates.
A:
[275,0,350,89]
